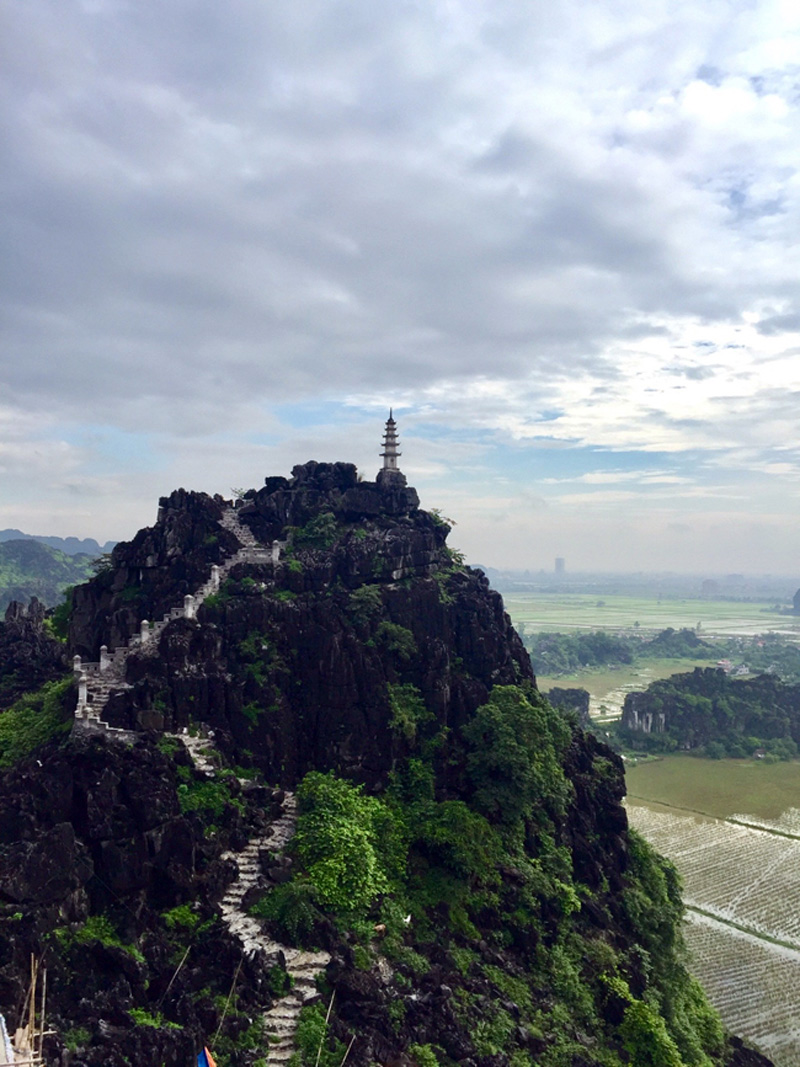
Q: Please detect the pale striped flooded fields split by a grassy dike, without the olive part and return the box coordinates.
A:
[628,802,800,1067]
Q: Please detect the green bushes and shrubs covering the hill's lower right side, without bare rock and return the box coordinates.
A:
[247,686,722,1067]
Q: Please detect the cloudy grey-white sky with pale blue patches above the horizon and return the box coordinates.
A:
[0,0,800,574]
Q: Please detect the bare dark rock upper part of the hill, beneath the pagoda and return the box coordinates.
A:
[70,462,533,785]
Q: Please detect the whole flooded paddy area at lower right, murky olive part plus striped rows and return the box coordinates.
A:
[627,757,800,1067]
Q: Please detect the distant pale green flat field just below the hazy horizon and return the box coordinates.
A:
[503,593,800,637]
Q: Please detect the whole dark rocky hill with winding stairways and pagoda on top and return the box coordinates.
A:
[0,456,768,1067]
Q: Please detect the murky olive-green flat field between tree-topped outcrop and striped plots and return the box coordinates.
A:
[625,755,800,818]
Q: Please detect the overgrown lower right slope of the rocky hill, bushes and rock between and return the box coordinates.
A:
[249,686,724,1067]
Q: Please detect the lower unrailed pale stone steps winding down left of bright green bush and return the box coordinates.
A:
[177,734,331,1067]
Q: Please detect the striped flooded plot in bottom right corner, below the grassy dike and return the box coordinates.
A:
[684,911,800,1067]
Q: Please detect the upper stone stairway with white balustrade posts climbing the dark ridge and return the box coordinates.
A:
[73,508,283,736]
